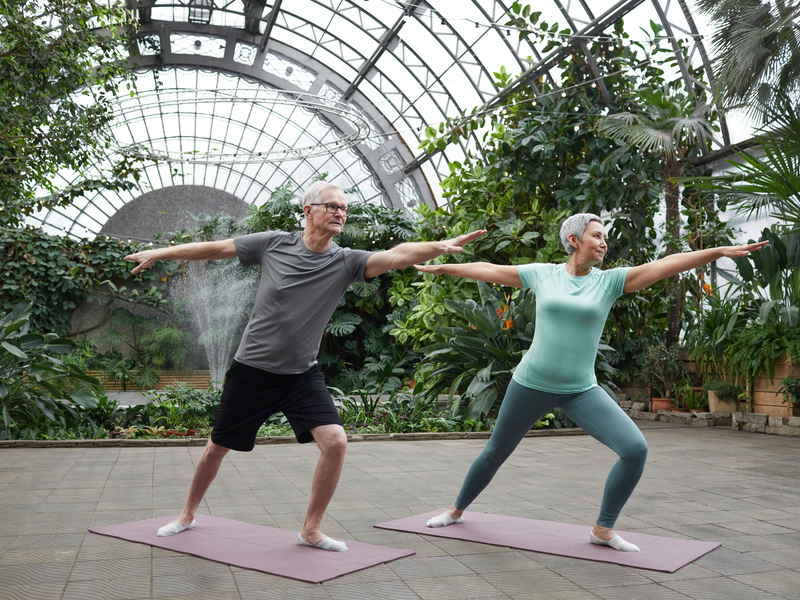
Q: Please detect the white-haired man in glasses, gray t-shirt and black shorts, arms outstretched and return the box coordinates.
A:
[125,181,486,552]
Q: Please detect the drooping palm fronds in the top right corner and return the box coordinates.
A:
[697,0,800,112]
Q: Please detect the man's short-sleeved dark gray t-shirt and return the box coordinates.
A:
[234,231,372,374]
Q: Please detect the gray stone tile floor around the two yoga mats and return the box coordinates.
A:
[0,422,800,600]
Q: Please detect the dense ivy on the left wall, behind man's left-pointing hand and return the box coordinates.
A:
[0,227,175,332]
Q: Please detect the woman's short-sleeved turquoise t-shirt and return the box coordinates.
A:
[514,263,630,394]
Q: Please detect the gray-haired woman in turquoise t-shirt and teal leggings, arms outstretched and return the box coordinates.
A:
[416,213,767,552]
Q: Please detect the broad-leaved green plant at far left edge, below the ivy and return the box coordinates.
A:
[0,304,100,438]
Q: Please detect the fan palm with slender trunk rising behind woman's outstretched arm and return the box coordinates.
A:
[597,89,713,347]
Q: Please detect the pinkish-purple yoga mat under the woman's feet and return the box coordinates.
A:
[375,509,721,573]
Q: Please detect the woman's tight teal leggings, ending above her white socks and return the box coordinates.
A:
[455,381,647,527]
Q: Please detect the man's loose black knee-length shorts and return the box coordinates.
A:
[211,360,342,452]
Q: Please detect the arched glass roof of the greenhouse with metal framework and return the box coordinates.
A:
[32,0,736,235]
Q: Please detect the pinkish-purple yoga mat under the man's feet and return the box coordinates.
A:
[89,515,414,583]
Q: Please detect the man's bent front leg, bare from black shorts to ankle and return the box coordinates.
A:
[300,425,347,546]
